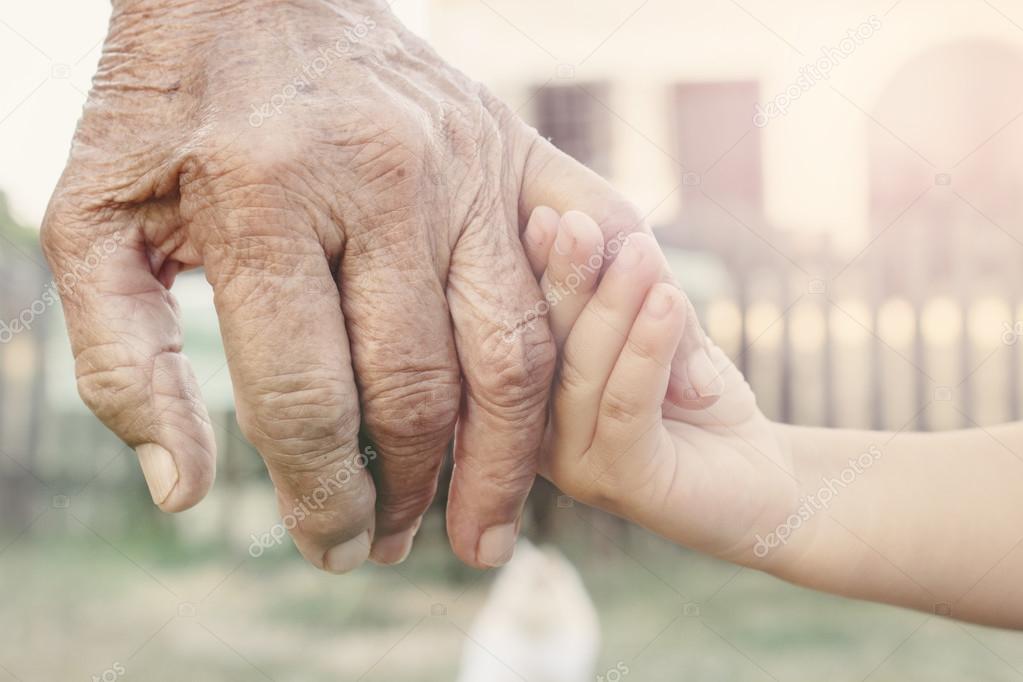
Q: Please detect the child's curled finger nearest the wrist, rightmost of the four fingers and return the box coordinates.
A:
[593,283,688,457]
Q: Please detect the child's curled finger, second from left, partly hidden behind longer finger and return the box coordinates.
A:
[540,211,604,348]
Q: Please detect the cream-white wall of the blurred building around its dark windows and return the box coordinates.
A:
[431,0,1023,249]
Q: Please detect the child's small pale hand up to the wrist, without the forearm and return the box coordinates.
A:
[527,206,798,563]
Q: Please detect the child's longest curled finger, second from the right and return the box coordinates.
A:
[553,234,663,453]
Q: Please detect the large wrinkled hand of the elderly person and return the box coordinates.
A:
[43,0,720,573]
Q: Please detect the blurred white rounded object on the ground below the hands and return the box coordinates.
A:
[458,541,601,682]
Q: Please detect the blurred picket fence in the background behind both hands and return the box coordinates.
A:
[0,237,1023,548]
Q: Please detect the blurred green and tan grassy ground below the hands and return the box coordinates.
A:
[0,503,1023,682]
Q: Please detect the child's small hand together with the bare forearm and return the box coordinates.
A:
[525,210,1023,628]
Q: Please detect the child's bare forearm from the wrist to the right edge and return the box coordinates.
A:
[761,423,1023,628]
